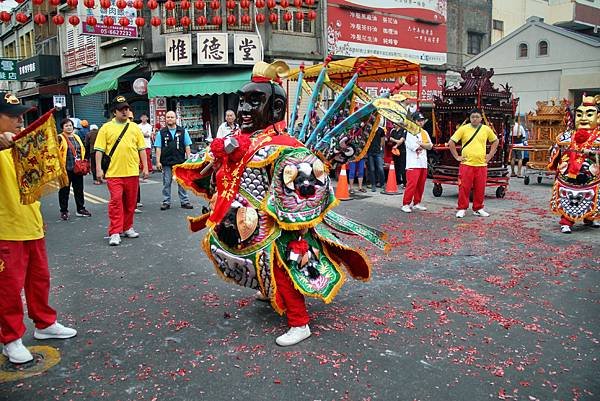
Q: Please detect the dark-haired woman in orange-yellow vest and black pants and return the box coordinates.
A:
[58,118,92,221]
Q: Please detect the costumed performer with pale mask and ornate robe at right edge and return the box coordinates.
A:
[548,95,600,234]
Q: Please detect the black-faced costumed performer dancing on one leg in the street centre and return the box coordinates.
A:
[174,61,394,346]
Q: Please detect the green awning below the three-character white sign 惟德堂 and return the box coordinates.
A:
[148,70,252,98]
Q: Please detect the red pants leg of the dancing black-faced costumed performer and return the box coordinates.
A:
[273,261,310,327]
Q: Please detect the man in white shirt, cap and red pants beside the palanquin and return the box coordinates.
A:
[402,112,433,213]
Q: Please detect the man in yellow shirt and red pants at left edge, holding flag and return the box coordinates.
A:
[0,92,77,363]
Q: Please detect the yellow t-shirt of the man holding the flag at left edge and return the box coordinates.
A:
[0,149,44,241]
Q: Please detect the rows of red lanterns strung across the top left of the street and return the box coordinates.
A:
[7,0,317,28]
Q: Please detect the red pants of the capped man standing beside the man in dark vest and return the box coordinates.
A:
[106,176,140,235]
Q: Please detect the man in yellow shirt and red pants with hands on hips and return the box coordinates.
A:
[448,109,498,218]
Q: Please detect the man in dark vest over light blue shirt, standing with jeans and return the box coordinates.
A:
[154,111,194,210]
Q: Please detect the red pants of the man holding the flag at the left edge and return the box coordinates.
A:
[0,238,56,344]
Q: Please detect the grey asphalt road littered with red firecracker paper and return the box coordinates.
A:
[0,174,600,401]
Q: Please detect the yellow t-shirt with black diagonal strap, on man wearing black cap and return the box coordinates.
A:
[94,119,146,178]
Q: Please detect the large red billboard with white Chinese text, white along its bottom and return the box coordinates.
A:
[327,0,447,65]
